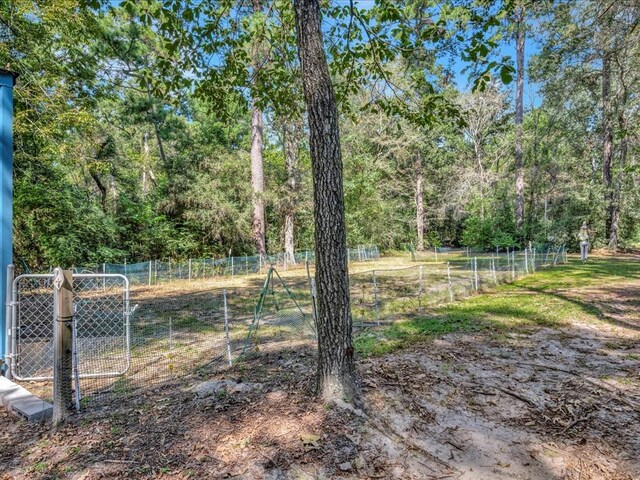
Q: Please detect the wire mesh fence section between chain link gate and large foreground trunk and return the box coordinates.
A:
[78,268,315,407]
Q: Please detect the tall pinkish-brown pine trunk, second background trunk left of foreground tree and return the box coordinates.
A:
[251,0,267,255]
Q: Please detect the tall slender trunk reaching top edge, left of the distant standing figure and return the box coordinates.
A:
[515,2,525,231]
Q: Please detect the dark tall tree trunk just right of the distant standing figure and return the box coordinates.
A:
[602,52,614,242]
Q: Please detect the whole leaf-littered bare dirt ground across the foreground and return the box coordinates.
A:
[0,257,640,479]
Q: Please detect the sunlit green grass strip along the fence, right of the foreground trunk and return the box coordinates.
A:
[355,257,640,356]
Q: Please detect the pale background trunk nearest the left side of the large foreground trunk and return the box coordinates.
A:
[283,119,298,263]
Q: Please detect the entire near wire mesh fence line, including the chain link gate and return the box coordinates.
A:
[8,248,566,414]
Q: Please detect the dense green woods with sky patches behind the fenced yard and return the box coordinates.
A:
[0,0,640,269]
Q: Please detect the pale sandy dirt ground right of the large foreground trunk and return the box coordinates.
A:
[359,268,640,479]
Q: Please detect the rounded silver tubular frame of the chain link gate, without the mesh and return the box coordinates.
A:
[6,272,132,381]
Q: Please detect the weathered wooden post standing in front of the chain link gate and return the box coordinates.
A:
[53,268,73,425]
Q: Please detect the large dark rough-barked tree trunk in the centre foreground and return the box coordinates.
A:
[294,0,360,403]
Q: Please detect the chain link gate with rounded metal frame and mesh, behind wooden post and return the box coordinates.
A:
[7,274,131,383]
